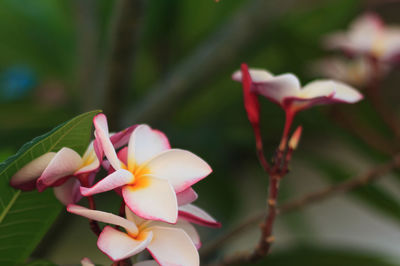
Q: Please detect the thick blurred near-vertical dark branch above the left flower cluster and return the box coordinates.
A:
[100,0,142,128]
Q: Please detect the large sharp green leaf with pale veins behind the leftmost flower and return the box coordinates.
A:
[0,111,100,265]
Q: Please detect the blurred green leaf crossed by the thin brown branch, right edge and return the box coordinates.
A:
[309,158,400,227]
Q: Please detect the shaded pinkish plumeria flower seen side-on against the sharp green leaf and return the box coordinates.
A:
[10,142,100,205]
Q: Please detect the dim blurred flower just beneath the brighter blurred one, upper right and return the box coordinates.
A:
[313,57,378,87]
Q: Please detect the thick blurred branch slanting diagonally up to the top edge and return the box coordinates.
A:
[123,0,323,124]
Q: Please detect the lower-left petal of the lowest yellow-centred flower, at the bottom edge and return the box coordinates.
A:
[97,226,153,261]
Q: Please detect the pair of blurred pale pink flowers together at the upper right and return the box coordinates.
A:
[315,13,400,86]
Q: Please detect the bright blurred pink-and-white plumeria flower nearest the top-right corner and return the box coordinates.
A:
[324,13,400,62]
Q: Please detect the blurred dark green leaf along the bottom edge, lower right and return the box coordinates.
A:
[253,247,395,266]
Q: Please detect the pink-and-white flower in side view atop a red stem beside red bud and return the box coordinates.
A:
[232,69,363,114]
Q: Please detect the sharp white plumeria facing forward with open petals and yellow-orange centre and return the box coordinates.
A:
[81,114,212,223]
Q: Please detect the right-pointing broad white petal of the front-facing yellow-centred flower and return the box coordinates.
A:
[146,149,212,193]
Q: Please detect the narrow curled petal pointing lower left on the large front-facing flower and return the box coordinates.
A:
[81,169,135,196]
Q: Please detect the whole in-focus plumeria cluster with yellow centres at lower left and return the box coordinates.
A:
[10,114,220,265]
